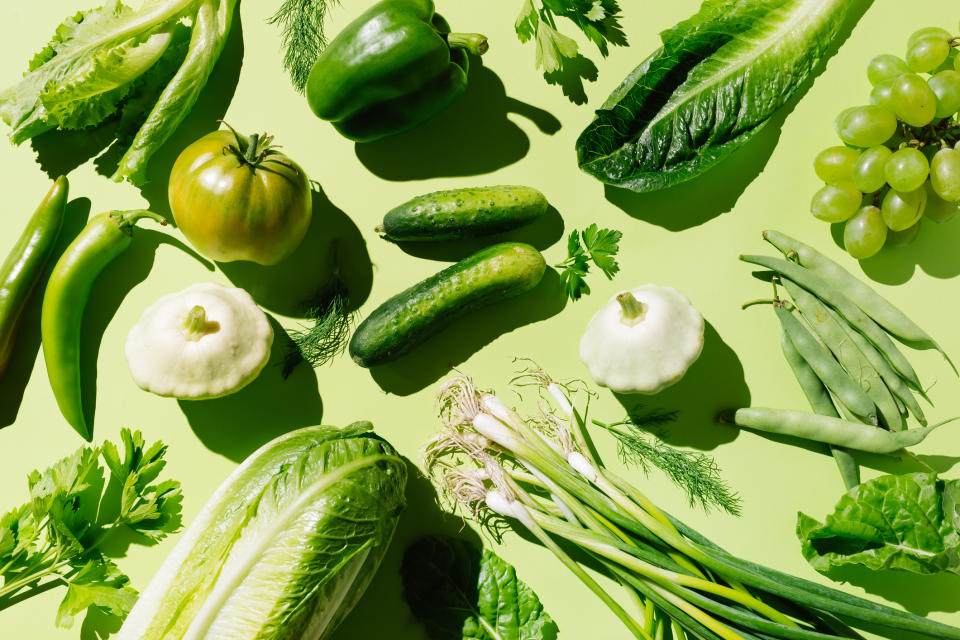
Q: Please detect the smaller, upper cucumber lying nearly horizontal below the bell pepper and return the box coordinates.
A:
[377,185,547,241]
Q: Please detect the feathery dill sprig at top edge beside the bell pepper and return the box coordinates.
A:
[267,0,339,93]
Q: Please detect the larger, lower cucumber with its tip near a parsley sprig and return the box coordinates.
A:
[350,242,547,367]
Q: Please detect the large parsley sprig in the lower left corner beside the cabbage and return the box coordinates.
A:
[0,429,181,628]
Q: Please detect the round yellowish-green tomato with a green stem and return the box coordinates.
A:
[168,125,312,265]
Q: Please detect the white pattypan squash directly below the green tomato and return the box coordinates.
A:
[125,283,273,400]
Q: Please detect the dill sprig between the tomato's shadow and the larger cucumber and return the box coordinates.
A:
[283,278,356,378]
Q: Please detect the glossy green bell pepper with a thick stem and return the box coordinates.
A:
[307,0,488,141]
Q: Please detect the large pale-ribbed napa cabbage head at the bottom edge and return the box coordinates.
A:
[117,422,406,640]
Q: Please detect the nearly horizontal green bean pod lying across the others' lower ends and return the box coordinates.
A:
[720,407,943,454]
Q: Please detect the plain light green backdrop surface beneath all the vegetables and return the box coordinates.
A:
[0,0,960,640]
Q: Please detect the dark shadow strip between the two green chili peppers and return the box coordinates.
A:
[0,198,90,429]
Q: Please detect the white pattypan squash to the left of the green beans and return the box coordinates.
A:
[580,284,703,393]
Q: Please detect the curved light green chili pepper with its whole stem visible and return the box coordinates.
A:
[40,210,167,441]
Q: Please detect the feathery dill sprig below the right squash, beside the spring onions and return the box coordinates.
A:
[593,411,740,516]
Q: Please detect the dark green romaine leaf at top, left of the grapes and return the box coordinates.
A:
[577,0,853,192]
